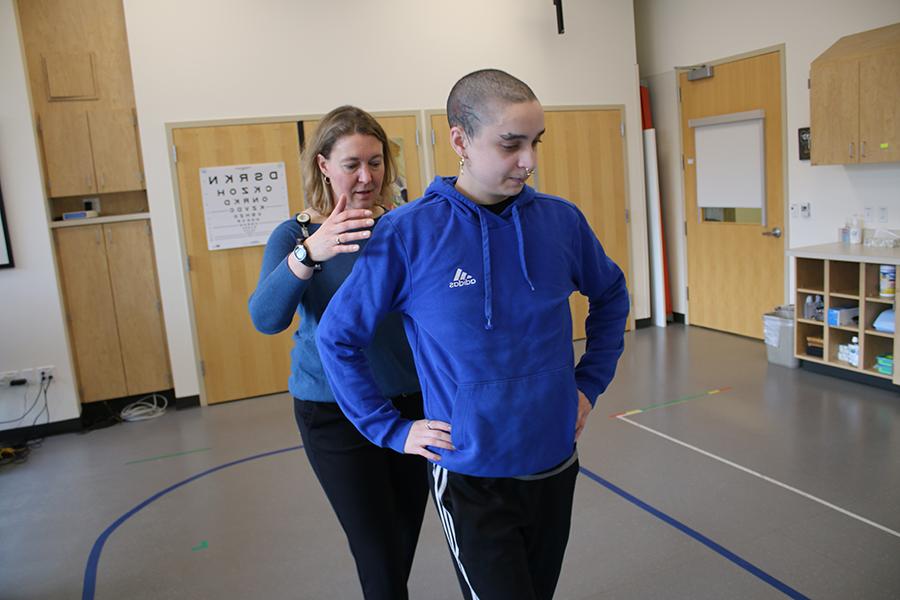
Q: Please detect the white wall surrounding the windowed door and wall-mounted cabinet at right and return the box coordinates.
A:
[634,0,900,312]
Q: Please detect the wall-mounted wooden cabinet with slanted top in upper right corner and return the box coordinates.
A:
[809,23,900,165]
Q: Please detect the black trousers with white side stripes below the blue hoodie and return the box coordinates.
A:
[428,461,578,600]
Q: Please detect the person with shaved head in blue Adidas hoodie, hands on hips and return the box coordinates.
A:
[317,69,629,600]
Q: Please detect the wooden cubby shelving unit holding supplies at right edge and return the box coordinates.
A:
[788,244,900,385]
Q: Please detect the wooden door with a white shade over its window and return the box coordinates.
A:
[679,52,784,339]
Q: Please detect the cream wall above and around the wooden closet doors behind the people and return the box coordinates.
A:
[124,0,649,404]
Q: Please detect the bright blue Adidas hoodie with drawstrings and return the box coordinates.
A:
[317,177,629,477]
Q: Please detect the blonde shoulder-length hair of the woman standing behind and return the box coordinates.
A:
[302,106,397,216]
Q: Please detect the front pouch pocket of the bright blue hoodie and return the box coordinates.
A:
[452,367,578,476]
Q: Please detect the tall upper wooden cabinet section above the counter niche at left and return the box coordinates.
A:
[17,0,144,198]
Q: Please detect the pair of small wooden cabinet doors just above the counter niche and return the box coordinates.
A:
[38,109,144,198]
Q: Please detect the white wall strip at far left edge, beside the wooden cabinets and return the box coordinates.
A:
[0,0,80,430]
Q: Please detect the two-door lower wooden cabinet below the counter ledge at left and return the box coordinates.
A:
[54,219,172,402]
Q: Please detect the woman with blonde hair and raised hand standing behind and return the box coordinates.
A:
[250,106,428,600]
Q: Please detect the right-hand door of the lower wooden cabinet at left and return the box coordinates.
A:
[103,220,172,396]
